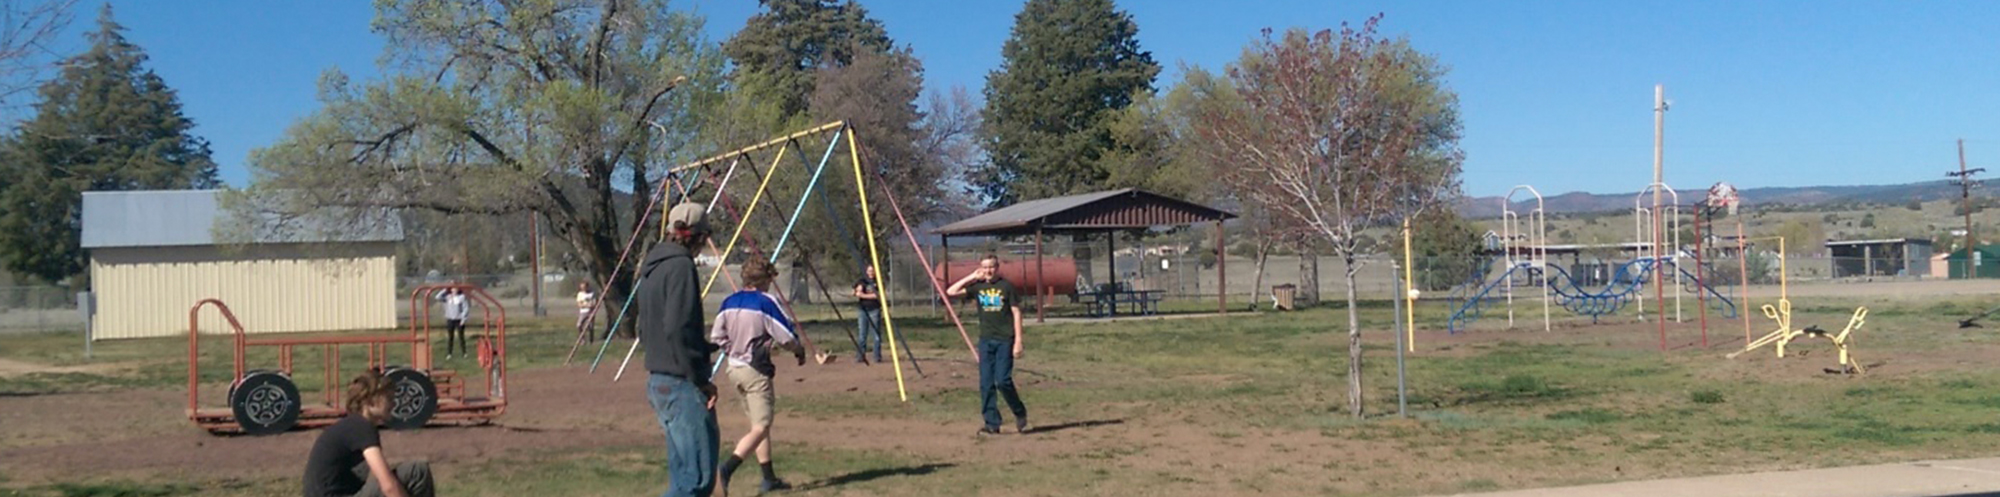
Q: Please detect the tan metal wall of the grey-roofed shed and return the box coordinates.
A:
[90,242,396,339]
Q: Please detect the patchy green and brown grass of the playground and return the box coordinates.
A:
[11,294,2000,495]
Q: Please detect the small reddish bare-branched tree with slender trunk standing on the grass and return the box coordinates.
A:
[1194,18,1462,417]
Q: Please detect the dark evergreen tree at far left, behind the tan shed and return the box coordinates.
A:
[0,4,218,287]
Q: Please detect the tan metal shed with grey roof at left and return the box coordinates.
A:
[82,190,402,339]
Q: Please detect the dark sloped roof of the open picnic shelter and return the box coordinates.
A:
[930,188,1236,234]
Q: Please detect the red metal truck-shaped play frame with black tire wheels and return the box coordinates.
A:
[188,285,506,435]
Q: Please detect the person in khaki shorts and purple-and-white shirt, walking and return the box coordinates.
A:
[708,259,806,495]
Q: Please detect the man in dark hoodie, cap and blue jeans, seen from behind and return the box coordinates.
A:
[634,202,718,497]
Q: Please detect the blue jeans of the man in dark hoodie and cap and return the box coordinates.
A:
[646,373,720,497]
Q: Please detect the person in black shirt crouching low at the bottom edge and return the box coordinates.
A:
[304,369,436,497]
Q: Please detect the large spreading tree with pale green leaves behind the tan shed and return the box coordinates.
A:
[232,0,724,310]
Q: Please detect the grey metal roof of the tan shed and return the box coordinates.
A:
[82,190,402,249]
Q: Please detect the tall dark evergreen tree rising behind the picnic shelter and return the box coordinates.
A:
[974,0,1160,206]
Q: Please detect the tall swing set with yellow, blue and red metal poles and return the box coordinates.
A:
[564,120,978,401]
